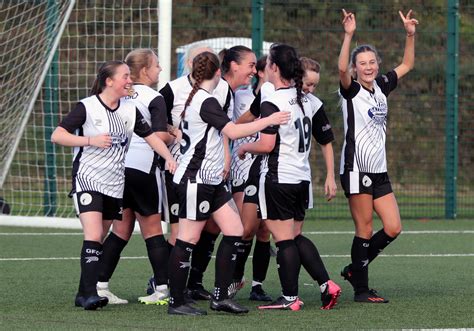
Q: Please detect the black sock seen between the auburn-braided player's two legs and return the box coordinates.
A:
[188,231,219,289]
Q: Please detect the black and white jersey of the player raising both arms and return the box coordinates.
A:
[339,70,397,174]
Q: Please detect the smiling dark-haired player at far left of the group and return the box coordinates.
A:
[51,61,176,310]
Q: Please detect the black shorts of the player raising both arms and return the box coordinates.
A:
[341,171,393,200]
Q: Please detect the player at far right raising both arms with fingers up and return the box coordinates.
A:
[338,9,418,303]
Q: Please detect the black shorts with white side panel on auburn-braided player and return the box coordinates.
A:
[178,179,232,221]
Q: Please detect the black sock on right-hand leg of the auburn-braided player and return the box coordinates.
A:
[213,236,242,301]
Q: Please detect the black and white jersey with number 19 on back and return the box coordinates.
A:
[261,87,334,184]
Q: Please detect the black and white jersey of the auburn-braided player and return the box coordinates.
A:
[173,89,230,185]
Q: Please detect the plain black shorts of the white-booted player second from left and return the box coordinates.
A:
[123,168,162,216]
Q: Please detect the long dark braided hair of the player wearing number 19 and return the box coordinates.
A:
[270,44,304,110]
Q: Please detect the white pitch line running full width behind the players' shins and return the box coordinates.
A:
[0,253,474,262]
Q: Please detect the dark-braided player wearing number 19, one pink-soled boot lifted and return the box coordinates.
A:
[239,44,340,310]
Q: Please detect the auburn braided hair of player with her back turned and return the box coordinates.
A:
[181,52,219,118]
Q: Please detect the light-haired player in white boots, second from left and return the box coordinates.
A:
[93,49,174,304]
